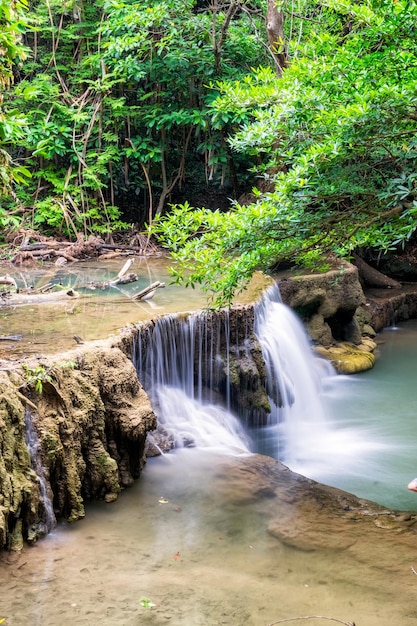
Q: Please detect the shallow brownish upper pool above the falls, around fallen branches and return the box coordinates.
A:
[0,257,267,359]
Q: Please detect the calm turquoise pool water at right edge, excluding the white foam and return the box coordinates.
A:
[321,320,417,510]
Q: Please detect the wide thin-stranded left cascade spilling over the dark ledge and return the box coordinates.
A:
[133,311,249,453]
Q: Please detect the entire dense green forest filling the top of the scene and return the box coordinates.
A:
[0,0,417,304]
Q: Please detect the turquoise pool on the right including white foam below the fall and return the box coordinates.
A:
[272,320,417,511]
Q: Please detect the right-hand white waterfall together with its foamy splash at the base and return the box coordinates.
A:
[255,288,389,481]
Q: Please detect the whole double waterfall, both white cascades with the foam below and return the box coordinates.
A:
[134,286,385,481]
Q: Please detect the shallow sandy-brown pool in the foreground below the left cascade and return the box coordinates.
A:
[0,449,417,626]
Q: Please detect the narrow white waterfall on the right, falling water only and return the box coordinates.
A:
[250,286,335,468]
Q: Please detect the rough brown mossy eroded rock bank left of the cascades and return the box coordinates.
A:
[0,342,156,549]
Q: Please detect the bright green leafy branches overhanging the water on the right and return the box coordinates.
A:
[155,0,417,305]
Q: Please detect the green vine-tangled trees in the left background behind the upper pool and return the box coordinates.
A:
[0,0,265,237]
